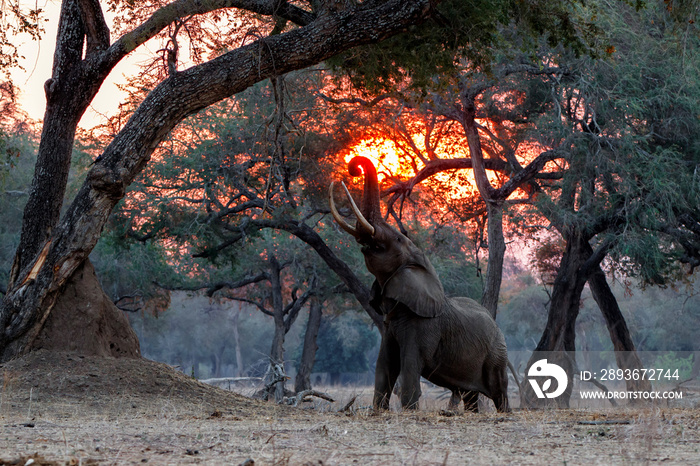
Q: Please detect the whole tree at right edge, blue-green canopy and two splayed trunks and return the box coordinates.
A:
[525,0,700,405]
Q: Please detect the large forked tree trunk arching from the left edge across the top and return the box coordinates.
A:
[0,0,430,361]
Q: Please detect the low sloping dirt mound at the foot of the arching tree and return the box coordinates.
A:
[0,350,279,416]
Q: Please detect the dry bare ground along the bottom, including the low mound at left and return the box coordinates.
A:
[0,351,700,465]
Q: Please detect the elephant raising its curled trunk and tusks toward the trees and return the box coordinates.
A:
[329,157,510,412]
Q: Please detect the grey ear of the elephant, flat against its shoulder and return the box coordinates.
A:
[384,266,446,317]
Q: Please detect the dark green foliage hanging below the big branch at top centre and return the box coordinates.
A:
[330,0,601,96]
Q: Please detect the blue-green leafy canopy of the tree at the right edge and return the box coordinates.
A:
[516,1,700,285]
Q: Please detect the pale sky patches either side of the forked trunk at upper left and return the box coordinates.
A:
[12,0,144,129]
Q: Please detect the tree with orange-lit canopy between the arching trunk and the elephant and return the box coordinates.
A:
[94,70,374,397]
